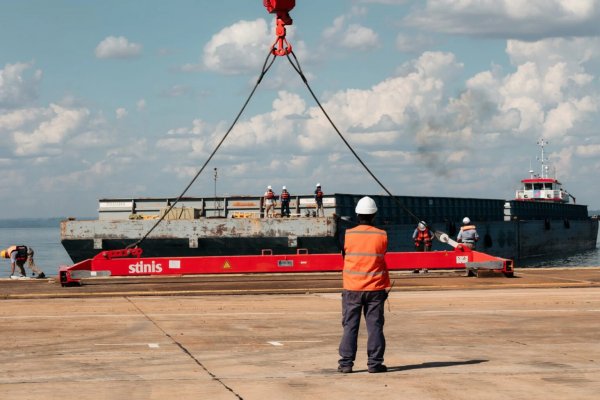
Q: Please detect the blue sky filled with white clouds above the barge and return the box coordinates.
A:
[0,0,600,218]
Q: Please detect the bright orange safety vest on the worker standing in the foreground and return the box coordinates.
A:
[342,225,391,291]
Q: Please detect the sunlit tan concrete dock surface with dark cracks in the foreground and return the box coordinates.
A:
[0,268,600,400]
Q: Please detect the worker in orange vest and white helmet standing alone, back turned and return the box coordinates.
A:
[338,197,391,373]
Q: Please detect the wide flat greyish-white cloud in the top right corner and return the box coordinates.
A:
[404,0,600,40]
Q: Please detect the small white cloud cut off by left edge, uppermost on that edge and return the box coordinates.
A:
[0,63,42,110]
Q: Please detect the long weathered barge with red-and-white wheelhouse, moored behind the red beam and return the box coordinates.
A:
[61,139,598,263]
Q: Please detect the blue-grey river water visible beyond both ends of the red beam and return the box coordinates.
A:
[0,227,600,278]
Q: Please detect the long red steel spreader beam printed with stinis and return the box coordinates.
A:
[59,245,513,286]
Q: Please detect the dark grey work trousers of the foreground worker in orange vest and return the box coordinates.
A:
[339,290,388,367]
